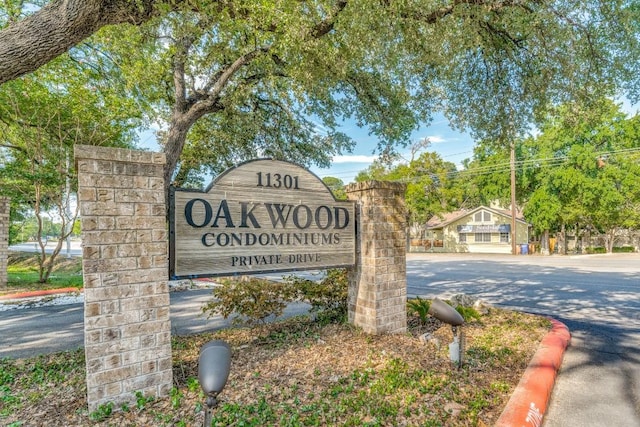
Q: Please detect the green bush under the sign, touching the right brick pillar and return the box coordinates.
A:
[285,268,349,321]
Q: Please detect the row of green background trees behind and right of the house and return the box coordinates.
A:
[356,98,640,252]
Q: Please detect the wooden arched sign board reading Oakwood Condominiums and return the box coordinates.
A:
[169,159,355,279]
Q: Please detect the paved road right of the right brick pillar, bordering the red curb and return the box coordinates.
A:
[407,254,640,427]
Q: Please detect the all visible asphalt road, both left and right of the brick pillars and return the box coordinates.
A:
[0,254,640,427]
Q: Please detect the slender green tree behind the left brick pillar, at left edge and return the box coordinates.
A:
[0,59,139,283]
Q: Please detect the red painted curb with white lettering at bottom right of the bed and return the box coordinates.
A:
[495,319,571,427]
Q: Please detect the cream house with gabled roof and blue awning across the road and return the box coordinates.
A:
[410,206,529,254]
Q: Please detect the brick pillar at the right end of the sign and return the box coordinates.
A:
[346,181,407,334]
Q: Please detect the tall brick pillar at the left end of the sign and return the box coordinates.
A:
[75,146,173,410]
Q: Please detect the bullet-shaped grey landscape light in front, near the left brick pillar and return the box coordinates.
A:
[198,340,231,427]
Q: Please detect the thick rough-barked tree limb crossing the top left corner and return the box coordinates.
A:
[0,0,174,84]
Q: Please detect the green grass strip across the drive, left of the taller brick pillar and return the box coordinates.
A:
[0,252,83,295]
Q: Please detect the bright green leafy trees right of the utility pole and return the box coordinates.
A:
[525,99,640,249]
